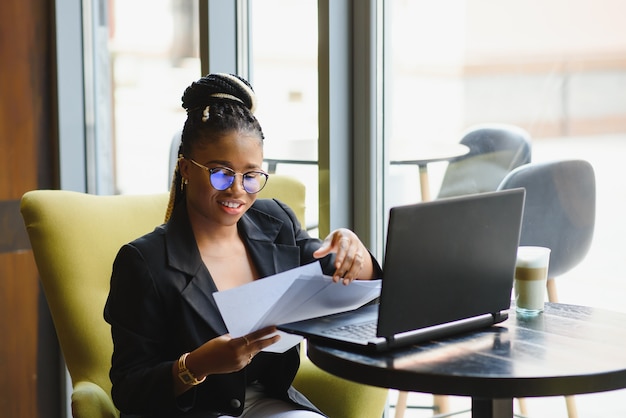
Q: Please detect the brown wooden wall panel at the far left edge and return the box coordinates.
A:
[0,0,64,418]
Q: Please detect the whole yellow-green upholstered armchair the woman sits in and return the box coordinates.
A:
[21,183,387,418]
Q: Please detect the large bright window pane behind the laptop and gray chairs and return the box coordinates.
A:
[385,0,626,308]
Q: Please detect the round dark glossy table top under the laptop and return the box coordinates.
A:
[307,303,626,399]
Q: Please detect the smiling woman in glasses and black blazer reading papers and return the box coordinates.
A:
[105,74,381,418]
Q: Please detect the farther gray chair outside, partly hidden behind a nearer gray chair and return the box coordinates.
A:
[437,123,531,198]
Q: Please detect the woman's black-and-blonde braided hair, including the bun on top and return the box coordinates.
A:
[165,74,264,222]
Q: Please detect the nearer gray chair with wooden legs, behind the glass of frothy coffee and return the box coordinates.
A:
[498,160,596,418]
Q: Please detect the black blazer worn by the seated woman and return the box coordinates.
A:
[104,199,380,417]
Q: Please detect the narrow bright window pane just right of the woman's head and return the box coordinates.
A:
[250,0,318,233]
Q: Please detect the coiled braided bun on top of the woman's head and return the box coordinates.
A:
[182,73,256,113]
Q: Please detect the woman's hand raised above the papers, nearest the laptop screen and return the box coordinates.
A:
[313,228,372,285]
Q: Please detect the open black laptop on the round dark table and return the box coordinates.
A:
[278,188,525,352]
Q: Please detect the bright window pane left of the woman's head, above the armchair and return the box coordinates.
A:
[110,0,200,193]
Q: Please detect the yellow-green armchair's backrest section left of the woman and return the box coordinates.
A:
[21,190,168,416]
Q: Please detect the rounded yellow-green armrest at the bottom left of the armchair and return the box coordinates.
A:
[72,381,119,418]
